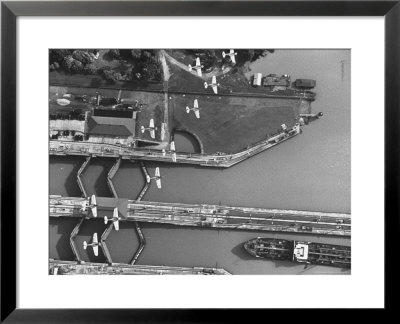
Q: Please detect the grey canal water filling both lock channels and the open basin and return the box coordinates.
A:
[50,50,351,274]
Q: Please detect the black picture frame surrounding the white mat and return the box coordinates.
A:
[1,0,400,323]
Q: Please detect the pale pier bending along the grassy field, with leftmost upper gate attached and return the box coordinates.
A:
[49,124,301,168]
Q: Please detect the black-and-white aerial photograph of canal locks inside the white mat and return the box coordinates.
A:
[48,48,351,275]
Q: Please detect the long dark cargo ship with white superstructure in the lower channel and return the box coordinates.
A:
[243,237,351,268]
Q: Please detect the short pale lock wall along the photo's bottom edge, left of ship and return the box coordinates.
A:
[49,259,230,275]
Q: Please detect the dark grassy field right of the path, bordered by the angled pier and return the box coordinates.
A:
[169,94,299,153]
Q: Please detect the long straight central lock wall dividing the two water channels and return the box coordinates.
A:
[50,196,351,236]
